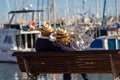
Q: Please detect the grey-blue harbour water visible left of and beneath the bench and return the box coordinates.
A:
[0,63,113,80]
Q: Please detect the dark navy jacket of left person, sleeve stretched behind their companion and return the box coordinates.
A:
[35,38,75,52]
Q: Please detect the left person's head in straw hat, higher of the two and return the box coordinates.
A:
[40,23,55,37]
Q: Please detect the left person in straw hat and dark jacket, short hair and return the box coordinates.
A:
[35,23,55,80]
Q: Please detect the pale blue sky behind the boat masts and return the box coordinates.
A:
[0,0,120,20]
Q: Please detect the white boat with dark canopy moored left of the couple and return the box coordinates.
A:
[0,10,41,62]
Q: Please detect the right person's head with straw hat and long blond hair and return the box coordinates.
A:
[54,28,71,46]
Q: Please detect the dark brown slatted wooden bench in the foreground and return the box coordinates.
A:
[13,50,120,77]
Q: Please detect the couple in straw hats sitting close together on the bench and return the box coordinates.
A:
[35,23,89,80]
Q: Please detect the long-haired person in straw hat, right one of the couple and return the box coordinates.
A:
[53,28,90,80]
